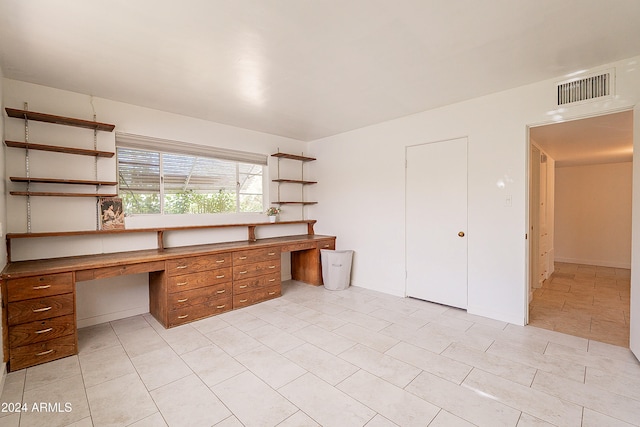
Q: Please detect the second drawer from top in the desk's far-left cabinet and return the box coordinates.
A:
[8,294,74,325]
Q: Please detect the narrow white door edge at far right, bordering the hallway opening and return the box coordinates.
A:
[629,105,640,360]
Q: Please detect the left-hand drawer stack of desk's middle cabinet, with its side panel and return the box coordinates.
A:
[149,252,233,328]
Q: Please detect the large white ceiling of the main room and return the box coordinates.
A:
[0,0,640,141]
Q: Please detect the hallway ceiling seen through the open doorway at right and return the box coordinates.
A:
[529,111,633,167]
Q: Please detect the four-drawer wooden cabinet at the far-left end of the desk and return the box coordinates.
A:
[4,273,78,371]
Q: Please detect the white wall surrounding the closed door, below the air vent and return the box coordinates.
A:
[311,58,640,324]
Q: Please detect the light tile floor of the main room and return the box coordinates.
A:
[0,282,640,427]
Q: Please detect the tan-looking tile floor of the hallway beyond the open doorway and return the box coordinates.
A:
[529,262,631,347]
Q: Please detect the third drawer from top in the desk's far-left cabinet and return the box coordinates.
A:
[9,314,76,348]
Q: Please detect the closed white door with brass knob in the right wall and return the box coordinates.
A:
[406,138,467,308]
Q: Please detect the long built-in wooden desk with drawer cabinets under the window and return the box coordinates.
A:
[2,231,335,371]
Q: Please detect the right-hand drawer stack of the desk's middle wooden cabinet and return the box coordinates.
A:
[233,247,282,309]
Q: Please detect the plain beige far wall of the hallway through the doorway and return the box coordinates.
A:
[555,162,633,268]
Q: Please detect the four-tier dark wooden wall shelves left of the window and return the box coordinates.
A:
[5,103,118,233]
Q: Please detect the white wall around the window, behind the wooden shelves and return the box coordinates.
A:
[0,79,313,327]
